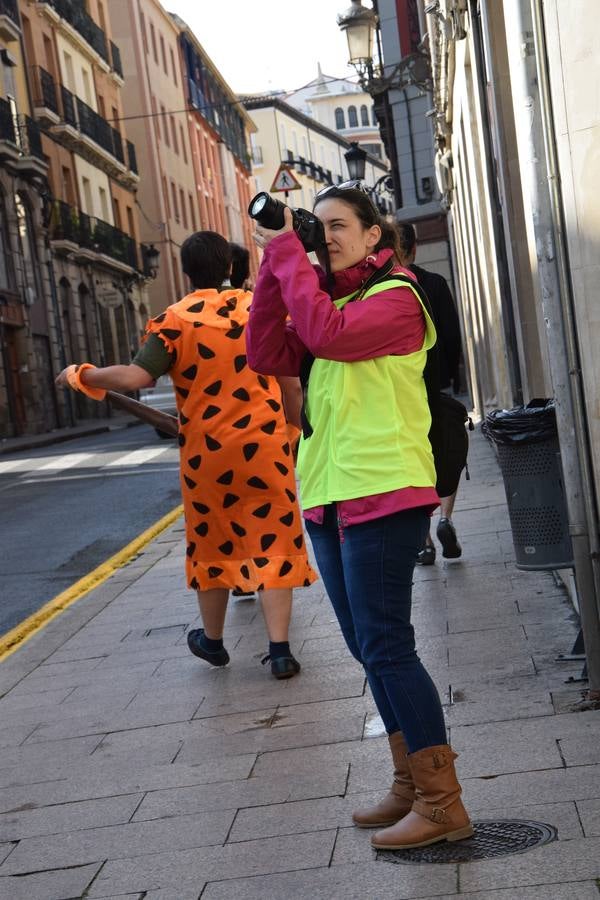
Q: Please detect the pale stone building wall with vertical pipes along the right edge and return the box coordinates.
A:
[422,0,600,691]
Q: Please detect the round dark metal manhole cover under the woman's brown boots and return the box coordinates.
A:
[377,819,556,864]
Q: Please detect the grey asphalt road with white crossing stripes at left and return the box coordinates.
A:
[0,424,181,635]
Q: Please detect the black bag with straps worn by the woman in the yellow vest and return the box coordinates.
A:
[300,259,474,497]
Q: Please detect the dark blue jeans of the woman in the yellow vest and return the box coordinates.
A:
[306,504,447,753]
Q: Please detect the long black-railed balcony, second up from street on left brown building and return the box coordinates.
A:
[32,66,139,186]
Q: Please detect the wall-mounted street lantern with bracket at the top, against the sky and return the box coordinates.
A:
[337,0,432,97]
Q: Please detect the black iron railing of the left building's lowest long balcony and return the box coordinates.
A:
[50,200,142,272]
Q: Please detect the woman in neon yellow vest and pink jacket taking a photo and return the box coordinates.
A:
[247,183,473,849]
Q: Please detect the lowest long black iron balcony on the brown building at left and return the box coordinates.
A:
[49,200,147,273]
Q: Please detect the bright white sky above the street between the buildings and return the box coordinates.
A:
[166,0,354,94]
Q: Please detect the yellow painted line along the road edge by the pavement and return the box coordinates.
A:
[0,506,183,662]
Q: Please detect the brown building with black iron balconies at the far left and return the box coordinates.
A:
[0,0,147,437]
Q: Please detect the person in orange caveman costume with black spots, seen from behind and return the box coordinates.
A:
[56,231,317,678]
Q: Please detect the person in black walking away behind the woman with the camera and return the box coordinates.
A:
[397,222,468,566]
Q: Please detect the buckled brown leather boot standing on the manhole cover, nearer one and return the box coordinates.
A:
[371,744,473,850]
